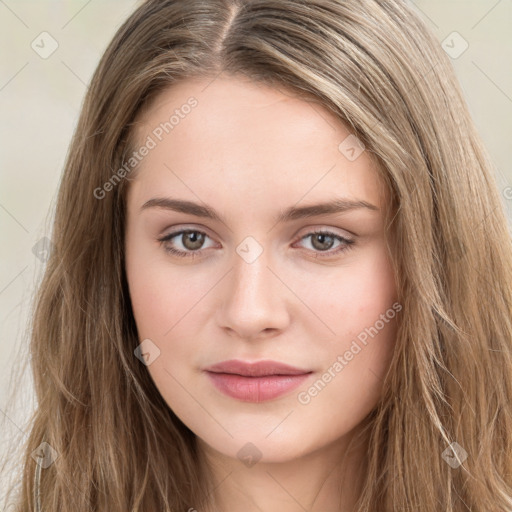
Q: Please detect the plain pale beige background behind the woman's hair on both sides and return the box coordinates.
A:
[0,0,512,500]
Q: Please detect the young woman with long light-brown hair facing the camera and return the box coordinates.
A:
[4,0,512,512]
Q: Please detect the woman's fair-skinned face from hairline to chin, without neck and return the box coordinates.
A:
[125,77,400,462]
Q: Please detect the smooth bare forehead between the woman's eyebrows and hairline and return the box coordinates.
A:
[128,76,385,214]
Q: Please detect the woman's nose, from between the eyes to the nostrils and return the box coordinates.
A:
[217,247,292,340]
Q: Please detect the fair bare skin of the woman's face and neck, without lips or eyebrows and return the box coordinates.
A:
[125,75,397,512]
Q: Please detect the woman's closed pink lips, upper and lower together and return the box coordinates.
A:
[205,360,312,402]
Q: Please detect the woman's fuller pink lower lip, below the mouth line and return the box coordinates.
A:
[206,372,310,402]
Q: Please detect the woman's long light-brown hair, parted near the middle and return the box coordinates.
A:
[3,0,512,512]
